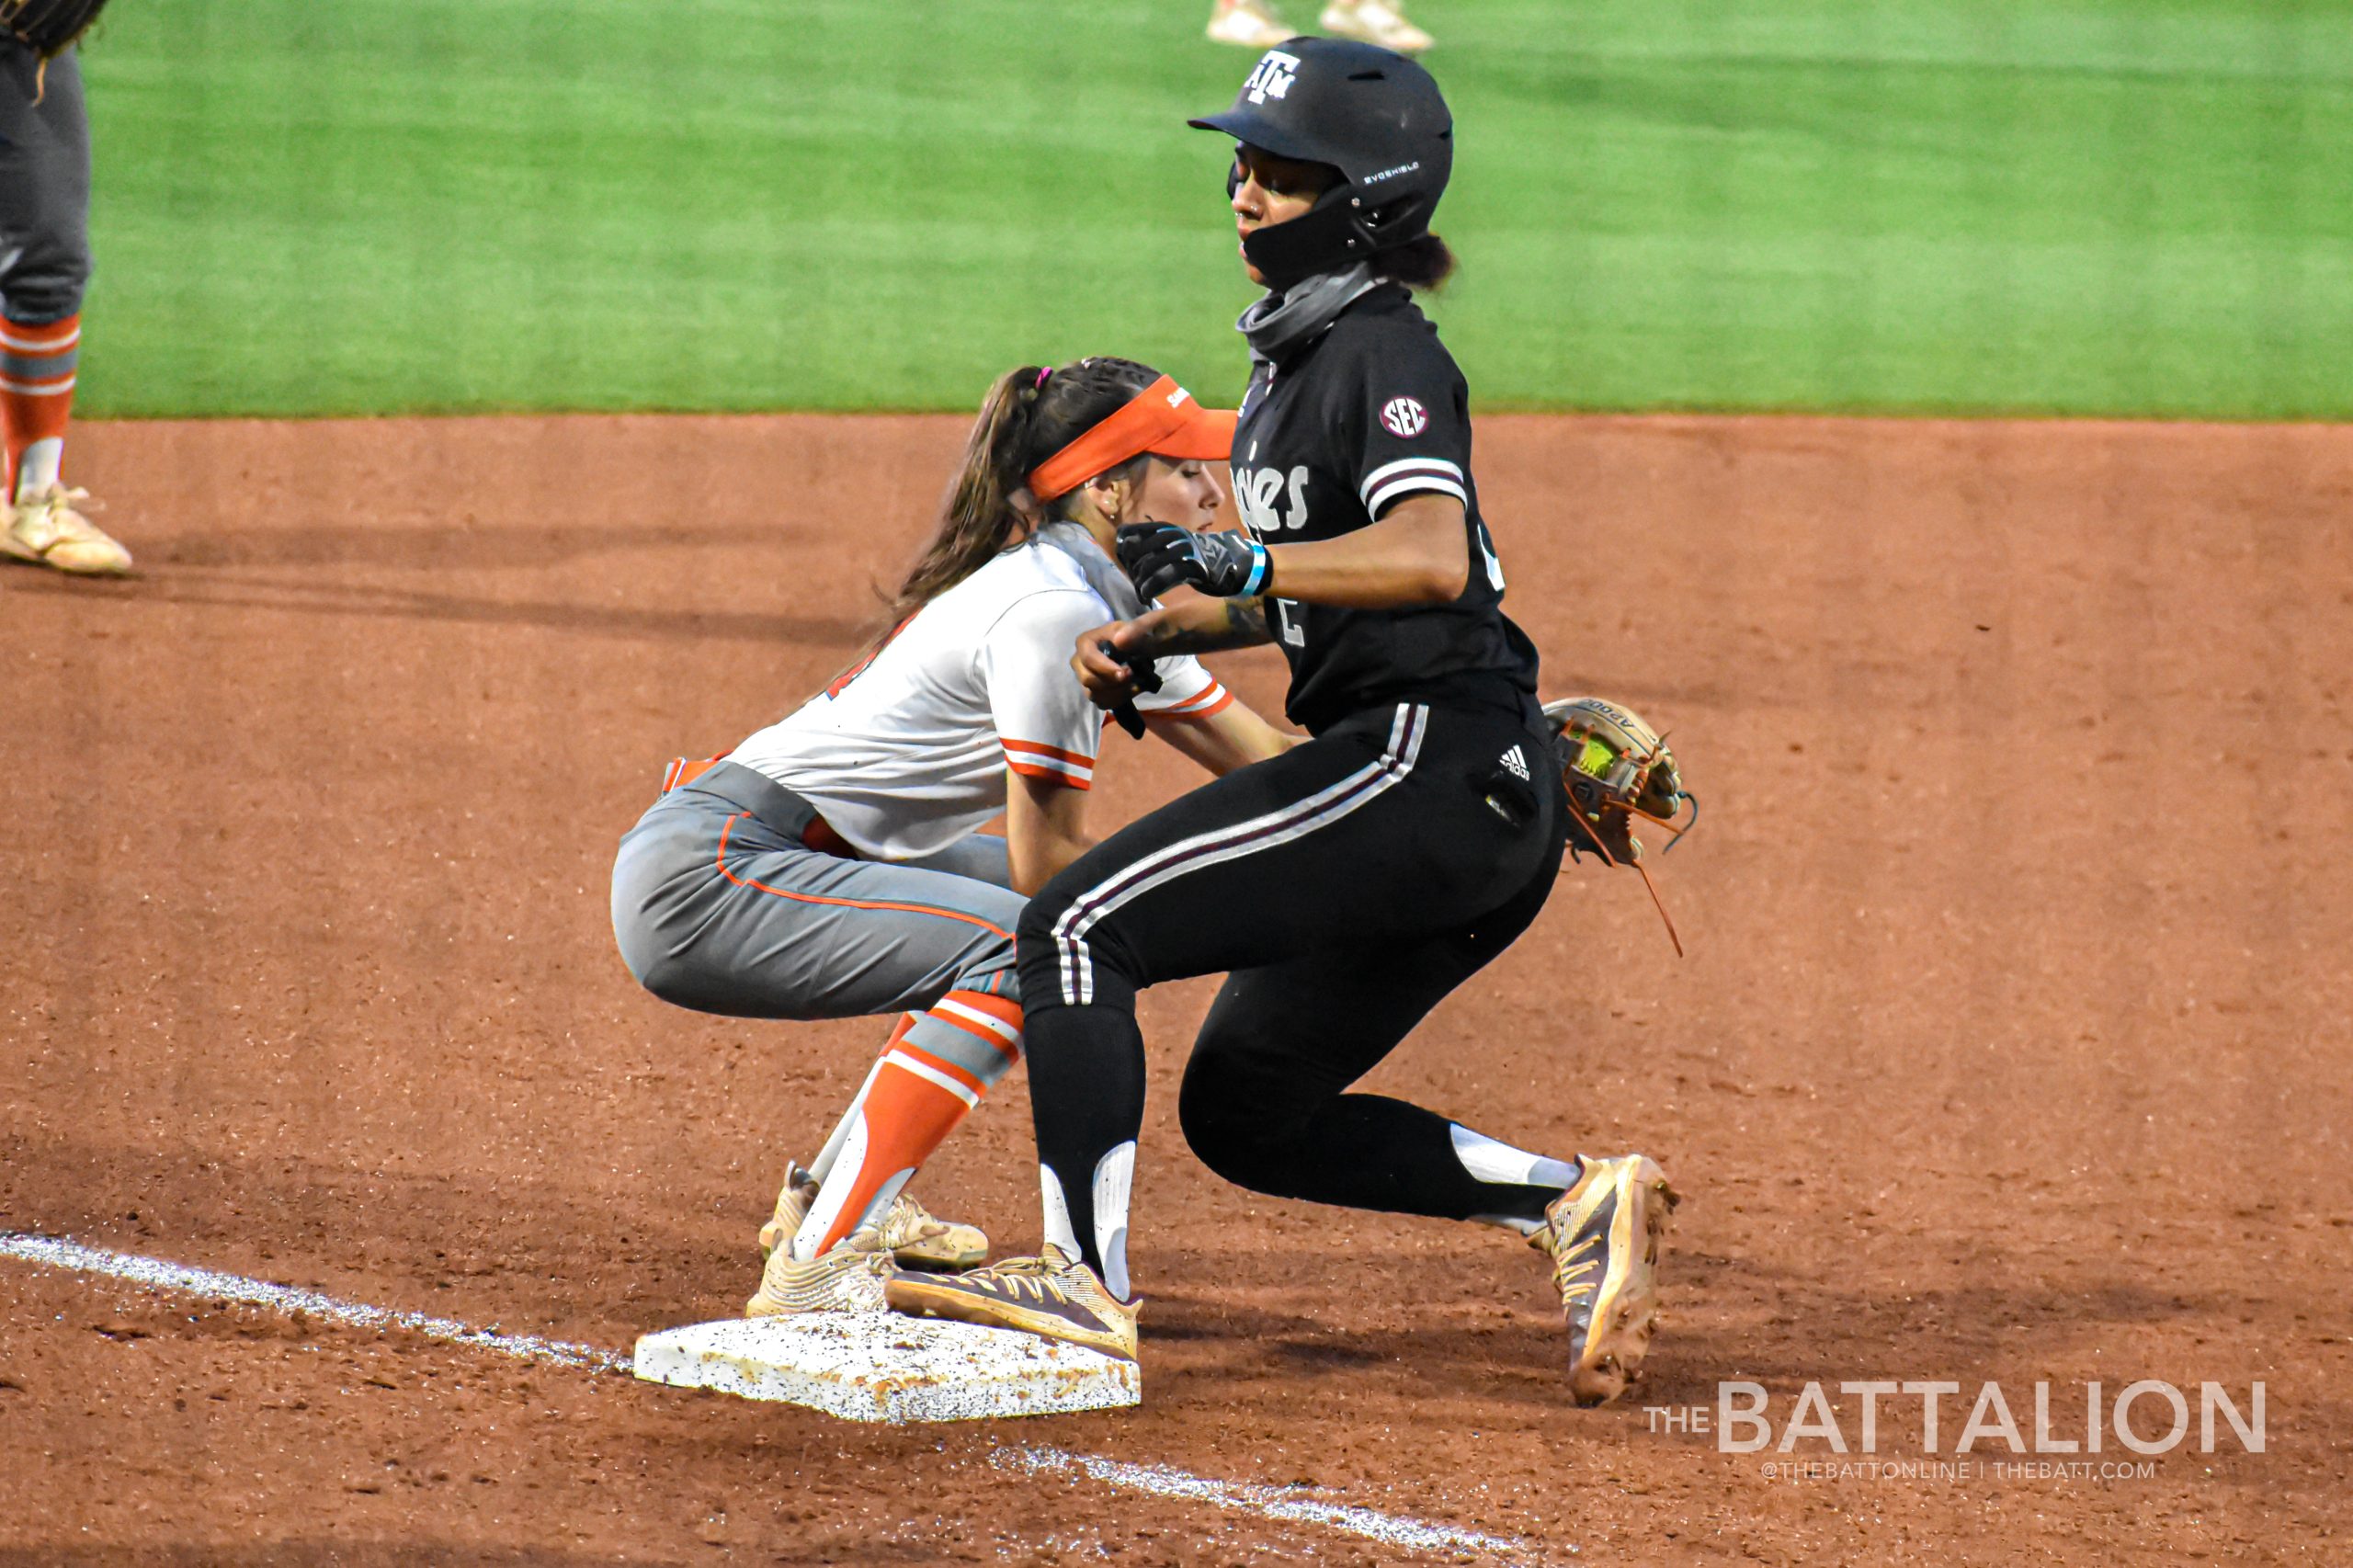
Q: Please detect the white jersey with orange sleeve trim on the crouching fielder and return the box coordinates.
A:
[727,541,1233,859]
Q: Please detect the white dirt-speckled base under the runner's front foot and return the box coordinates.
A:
[635,1312,1143,1425]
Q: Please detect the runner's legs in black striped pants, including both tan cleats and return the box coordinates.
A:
[887,709,1673,1403]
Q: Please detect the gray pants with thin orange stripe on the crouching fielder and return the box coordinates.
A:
[612,763,1026,1026]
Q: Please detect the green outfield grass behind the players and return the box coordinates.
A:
[83,0,2353,419]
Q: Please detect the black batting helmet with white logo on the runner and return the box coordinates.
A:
[1188,38,1454,290]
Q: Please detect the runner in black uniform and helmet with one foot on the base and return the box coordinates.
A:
[890,38,1673,1403]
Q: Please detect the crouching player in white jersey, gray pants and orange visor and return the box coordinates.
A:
[612,358,1290,1316]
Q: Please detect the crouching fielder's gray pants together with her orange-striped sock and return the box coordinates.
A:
[612,763,1024,1257]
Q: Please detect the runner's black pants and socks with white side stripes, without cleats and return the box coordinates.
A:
[1018,704,1567,1292]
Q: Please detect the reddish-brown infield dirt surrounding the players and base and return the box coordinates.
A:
[0,416,2353,1568]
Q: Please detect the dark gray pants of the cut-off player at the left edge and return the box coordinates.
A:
[0,40,89,322]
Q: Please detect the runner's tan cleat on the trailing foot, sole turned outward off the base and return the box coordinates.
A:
[1527,1153,1682,1405]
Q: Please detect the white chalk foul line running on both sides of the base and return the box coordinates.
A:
[14,1232,1576,1563]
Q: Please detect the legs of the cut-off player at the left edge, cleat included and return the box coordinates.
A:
[0,42,131,574]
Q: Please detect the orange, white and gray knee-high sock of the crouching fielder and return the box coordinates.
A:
[793,991,1021,1262]
